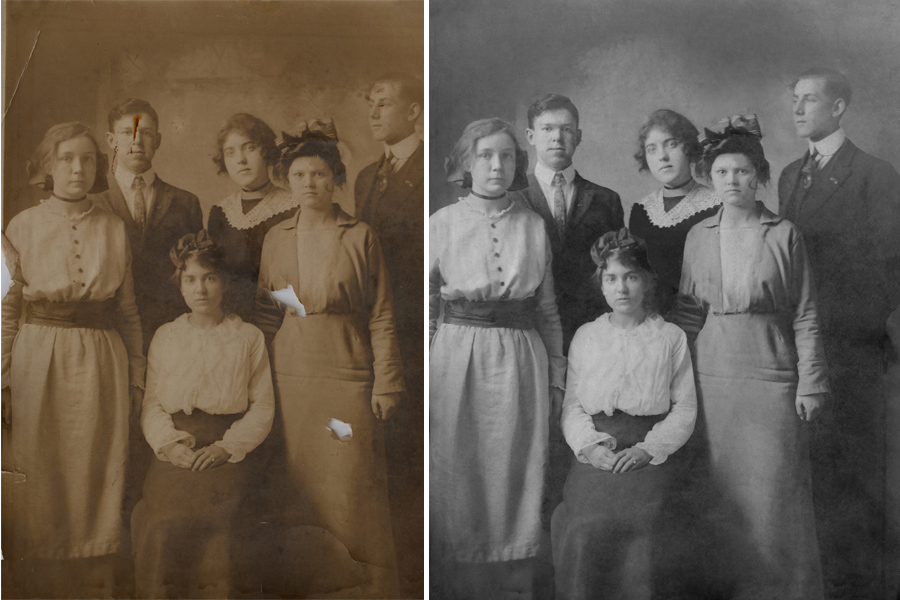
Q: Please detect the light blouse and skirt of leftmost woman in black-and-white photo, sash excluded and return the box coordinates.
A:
[429,195,566,562]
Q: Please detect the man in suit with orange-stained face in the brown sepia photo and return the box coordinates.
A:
[93,98,203,353]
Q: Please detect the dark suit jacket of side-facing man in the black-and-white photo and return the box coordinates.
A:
[778,140,900,340]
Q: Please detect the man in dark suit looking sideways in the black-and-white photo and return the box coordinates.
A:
[778,69,900,598]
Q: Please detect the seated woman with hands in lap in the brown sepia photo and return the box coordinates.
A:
[131,231,275,598]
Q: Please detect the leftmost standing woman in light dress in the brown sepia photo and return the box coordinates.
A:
[3,123,145,597]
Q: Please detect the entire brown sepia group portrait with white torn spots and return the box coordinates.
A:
[2,1,426,598]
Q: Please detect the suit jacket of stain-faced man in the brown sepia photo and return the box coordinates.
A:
[91,176,203,354]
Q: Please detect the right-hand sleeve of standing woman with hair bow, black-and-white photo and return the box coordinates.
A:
[790,231,830,396]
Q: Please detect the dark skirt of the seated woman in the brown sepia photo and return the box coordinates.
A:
[131,410,250,598]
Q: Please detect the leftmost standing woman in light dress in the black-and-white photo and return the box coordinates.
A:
[429,119,565,598]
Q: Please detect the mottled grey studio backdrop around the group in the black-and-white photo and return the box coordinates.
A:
[429,0,900,599]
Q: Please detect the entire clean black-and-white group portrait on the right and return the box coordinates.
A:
[428,0,900,600]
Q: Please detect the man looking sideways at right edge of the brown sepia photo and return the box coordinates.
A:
[355,73,425,593]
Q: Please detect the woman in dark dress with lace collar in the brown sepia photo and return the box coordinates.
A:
[207,113,298,320]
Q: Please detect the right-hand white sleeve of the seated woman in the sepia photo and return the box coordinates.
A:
[214,325,275,462]
